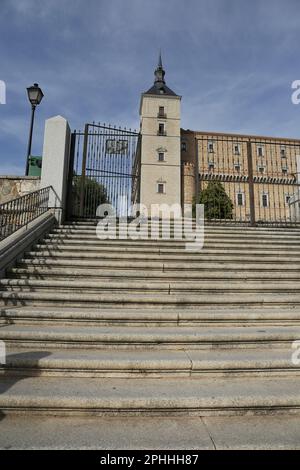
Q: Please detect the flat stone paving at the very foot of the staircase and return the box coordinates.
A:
[0,411,300,450]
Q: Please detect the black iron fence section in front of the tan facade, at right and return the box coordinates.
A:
[196,134,300,225]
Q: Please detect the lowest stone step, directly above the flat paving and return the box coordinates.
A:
[0,377,300,416]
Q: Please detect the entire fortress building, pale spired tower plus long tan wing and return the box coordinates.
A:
[134,56,300,223]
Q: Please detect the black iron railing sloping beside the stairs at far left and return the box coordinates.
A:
[0,186,52,240]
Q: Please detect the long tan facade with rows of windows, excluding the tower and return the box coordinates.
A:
[181,129,300,222]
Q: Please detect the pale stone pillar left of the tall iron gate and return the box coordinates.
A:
[41,116,71,223]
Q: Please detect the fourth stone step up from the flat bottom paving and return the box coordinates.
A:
[0,306,300,326]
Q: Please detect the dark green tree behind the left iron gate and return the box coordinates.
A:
[72,176,109,218]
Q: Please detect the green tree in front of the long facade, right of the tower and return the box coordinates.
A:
[198,181,233,220]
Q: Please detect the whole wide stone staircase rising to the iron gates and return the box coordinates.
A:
[0,221,300,416]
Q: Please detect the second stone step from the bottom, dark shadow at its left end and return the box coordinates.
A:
[0,348,300,378]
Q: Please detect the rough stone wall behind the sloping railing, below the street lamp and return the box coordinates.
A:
[0,176,41,204]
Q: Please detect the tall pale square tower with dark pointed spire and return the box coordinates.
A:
[140,54,181,216]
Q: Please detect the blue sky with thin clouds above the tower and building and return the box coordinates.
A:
[0,0,300,175]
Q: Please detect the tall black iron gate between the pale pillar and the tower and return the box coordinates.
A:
[68,124,139,218]
